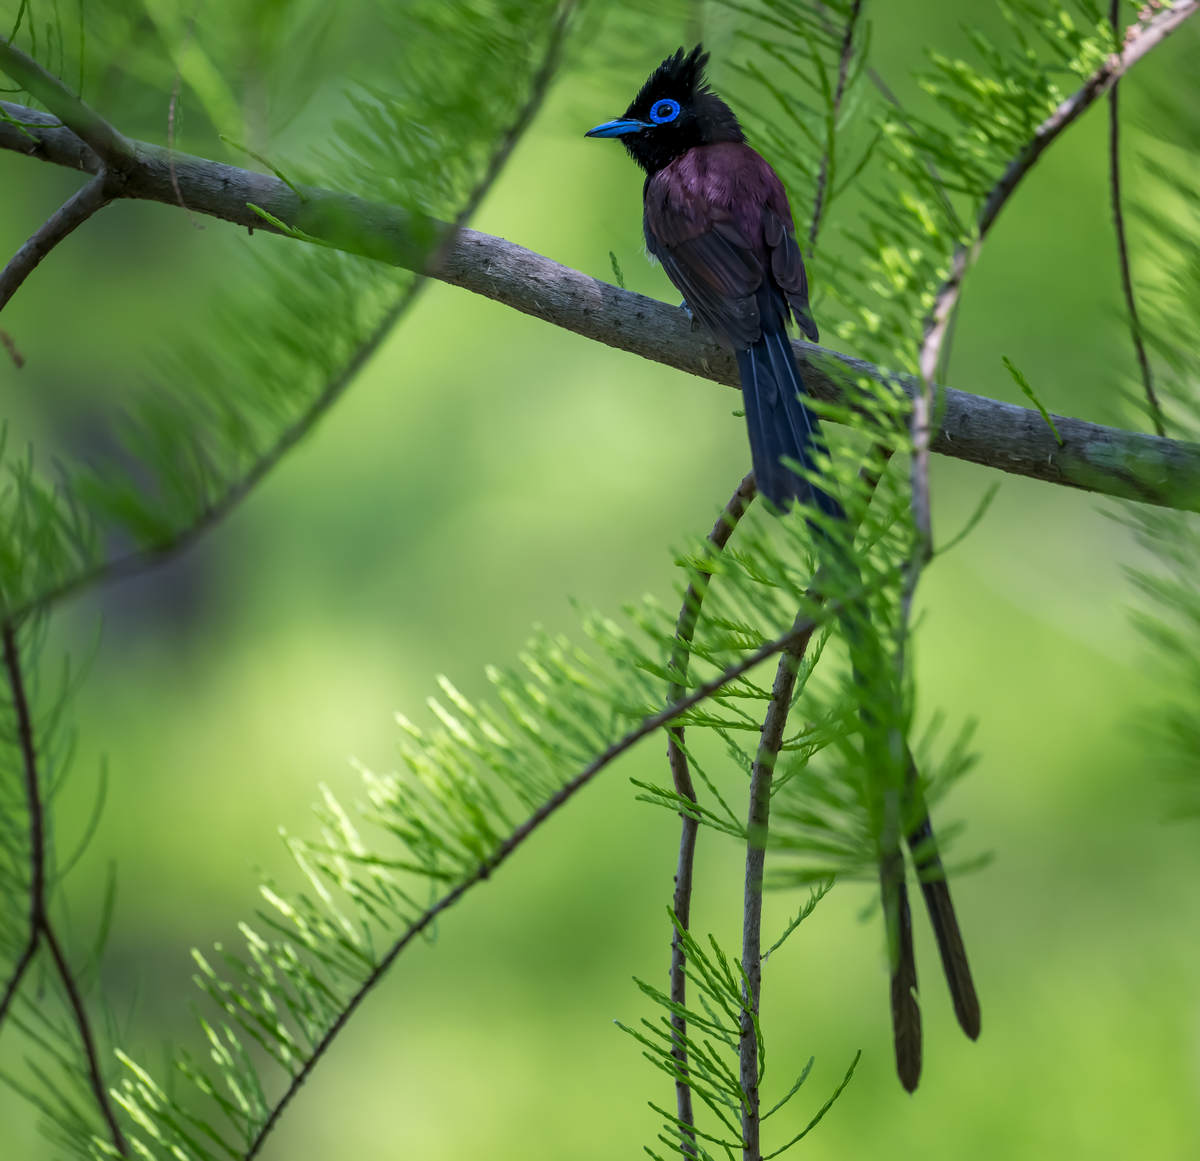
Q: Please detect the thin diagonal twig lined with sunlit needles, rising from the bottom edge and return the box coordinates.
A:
[244,599,818,1161]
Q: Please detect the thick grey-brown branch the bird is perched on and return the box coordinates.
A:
[0,100,1200,511]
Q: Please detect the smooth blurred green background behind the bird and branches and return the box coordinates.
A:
[0,0,1200,1161]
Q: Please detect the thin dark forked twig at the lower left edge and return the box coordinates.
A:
[0,618,128,1157]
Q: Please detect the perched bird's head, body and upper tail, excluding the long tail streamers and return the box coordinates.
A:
[586,44,842,518]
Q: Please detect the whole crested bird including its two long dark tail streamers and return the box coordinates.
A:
[584,44,980,1093]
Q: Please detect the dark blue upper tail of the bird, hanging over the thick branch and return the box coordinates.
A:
[737,326,844,519]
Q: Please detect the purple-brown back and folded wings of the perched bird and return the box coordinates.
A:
[643,142,816,349]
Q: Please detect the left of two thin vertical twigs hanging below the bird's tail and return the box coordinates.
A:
[667,471,757,1157]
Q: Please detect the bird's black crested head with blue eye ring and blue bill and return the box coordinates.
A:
[586,44,745,174]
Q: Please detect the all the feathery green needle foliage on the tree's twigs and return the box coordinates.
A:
[0,0,1200,1159]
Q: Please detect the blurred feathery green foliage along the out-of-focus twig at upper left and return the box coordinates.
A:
[0,0,558,615]
